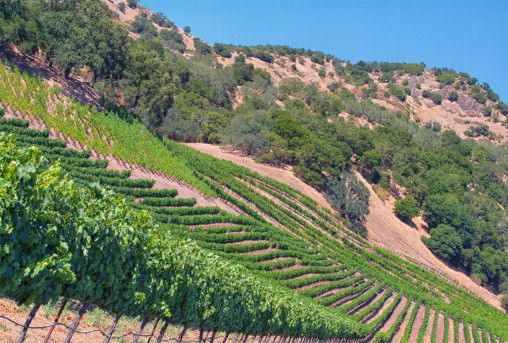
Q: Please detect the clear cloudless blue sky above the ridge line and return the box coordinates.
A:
[140,0,508,102]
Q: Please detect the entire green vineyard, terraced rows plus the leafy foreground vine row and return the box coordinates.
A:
[0,59,508,343]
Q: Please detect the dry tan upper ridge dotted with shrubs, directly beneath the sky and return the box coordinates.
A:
[103,0,508,143]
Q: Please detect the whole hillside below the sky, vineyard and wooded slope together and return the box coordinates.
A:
[0,0,508,343]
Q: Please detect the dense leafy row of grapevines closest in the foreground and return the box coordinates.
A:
[0,134,374,338]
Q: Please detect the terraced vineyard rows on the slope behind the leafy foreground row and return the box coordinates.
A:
[0,61,508,341]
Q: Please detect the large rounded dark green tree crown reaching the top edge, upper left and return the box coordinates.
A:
[41,0,128,82]
